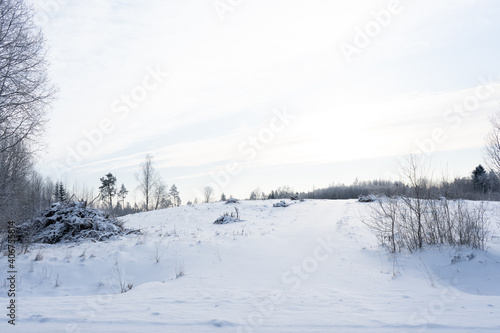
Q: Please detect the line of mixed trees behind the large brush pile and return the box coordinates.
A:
[0,152,182,229]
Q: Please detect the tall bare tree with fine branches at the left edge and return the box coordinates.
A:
[0,0,55,224]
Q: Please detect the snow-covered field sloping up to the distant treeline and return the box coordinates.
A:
[0,200,500,333]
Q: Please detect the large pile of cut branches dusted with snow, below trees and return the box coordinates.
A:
[18,202,135,244]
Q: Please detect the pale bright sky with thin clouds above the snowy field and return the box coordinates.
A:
[31,0,500,202]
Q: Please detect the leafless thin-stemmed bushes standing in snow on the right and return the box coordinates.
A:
[364,197,490,252]
